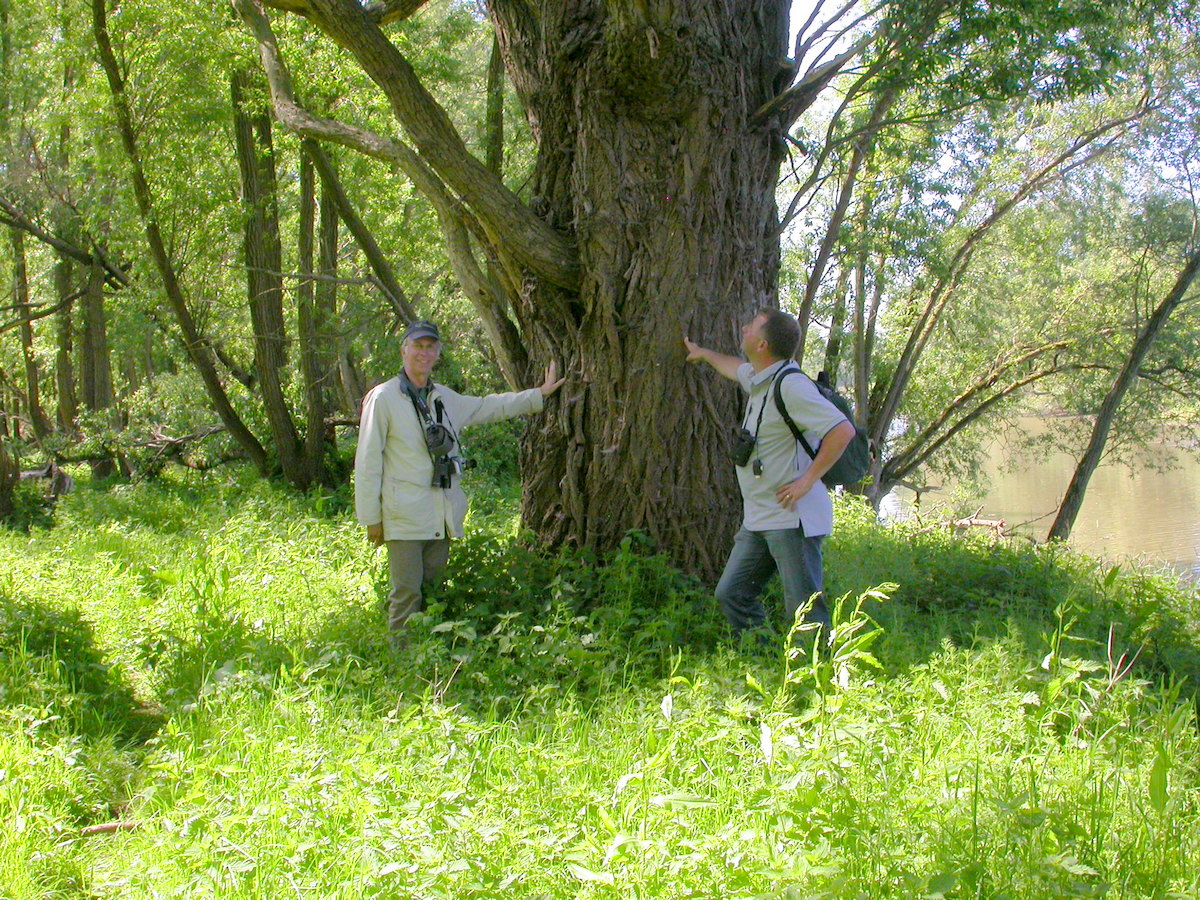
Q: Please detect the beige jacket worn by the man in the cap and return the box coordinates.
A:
[354,378,544,541]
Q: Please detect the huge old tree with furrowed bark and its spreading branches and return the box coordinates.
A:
[234,0,1161,572]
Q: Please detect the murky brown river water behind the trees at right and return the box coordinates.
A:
[895,416,1200,581]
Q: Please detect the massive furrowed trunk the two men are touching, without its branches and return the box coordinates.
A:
[490,0,787,576]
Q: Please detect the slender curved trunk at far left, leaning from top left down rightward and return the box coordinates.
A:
[91,0,268,473]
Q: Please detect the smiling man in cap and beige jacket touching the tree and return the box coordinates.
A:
[354,319,564,637]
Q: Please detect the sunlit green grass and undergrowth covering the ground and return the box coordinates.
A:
[0,475,1200,900]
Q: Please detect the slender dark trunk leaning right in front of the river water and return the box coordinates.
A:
[1046,244,1200,541]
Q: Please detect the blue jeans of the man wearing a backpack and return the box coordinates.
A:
[716,528,830,637]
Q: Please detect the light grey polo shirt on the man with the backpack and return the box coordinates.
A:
[736,360,846,538]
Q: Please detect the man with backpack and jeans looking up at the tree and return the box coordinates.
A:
[684,310,854,640]
